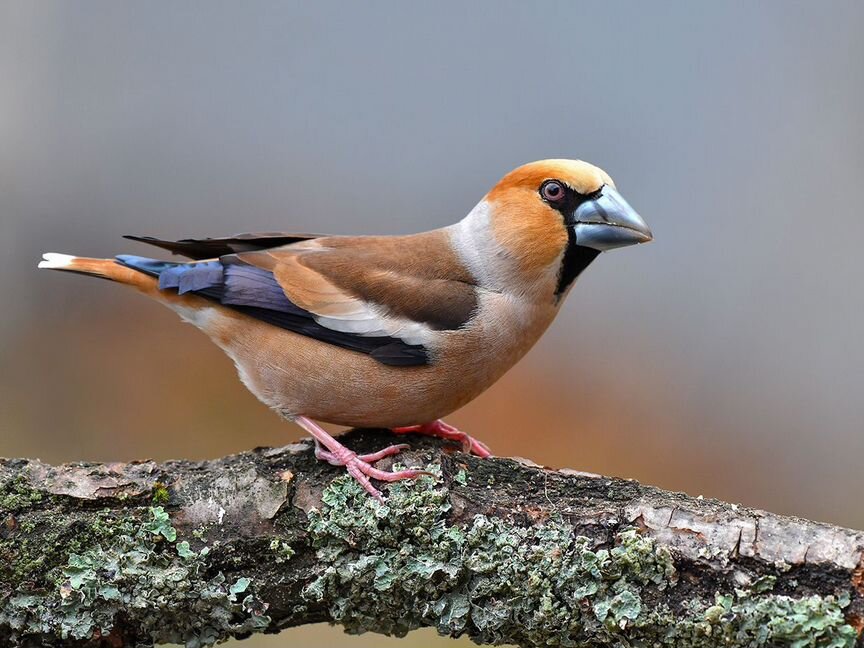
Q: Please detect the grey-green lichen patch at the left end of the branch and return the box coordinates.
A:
[0,506,270,648]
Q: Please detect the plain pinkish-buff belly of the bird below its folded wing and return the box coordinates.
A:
[199,306,552,427]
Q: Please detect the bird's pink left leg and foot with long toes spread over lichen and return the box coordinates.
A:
[294,416,429,501]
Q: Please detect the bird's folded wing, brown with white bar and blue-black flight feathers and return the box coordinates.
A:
[124,232,477,366]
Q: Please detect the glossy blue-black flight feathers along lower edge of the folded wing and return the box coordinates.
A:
[117,254,429,367]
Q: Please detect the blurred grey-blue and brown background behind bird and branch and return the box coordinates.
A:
[0,1,864,647]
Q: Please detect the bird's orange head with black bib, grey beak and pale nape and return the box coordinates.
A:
[462,160,653,296]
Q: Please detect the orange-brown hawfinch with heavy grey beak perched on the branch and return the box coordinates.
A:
[38,159,653,501]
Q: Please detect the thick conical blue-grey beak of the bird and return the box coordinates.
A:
[573,185,654,252]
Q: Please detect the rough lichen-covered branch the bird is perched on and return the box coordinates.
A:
[0,431,864,647]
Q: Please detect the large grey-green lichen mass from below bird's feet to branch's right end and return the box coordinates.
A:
[303,466,856,648]
